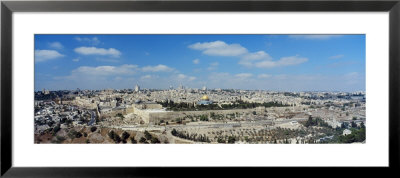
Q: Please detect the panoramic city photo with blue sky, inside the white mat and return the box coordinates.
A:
[33,35,366,144]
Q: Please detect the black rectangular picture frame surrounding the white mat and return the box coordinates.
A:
[0,0,400,177]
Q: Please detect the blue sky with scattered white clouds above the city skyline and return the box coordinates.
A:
[35,35,365,92]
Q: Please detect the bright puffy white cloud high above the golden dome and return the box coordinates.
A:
[188,41,247,56]
